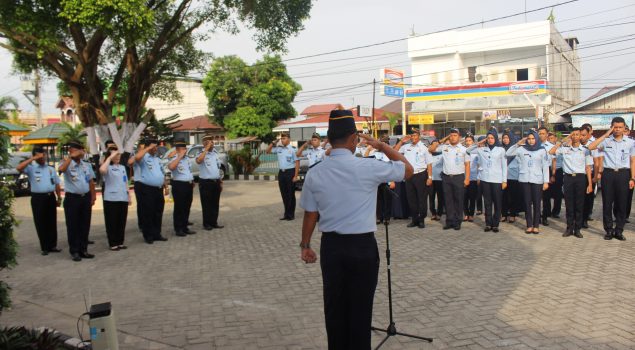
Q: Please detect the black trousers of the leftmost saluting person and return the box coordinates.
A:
[31,192,57,252]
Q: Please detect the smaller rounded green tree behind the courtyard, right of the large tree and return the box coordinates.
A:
[203,55,302,137]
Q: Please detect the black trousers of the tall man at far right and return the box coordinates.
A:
[601,168,630,234]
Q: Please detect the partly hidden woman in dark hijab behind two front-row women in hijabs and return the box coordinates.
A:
[501,131,524,224]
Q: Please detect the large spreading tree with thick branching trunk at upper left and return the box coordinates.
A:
[0,0,311,155]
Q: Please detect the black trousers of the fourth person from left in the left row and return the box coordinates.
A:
[137,182,165,240]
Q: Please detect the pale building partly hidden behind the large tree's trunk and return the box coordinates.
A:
[145,77,209,120]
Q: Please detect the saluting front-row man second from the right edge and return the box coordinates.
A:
[549,128,593,238]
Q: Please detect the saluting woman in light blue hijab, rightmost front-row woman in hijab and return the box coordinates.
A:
[507,130,550,234]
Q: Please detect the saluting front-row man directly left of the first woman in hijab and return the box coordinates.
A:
[428,129,470,230]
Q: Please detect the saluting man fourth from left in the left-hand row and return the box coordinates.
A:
[133,138,168,244]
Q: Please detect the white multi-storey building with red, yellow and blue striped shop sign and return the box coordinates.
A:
[405,21,580,134]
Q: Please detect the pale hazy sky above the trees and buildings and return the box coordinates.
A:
[0,0,635,114]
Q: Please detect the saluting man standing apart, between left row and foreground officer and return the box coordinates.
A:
[267,133,300,221]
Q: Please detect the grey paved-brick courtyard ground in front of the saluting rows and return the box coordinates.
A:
[0,182,635,349]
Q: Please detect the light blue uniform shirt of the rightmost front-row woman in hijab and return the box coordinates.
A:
[507,145,551,184]
